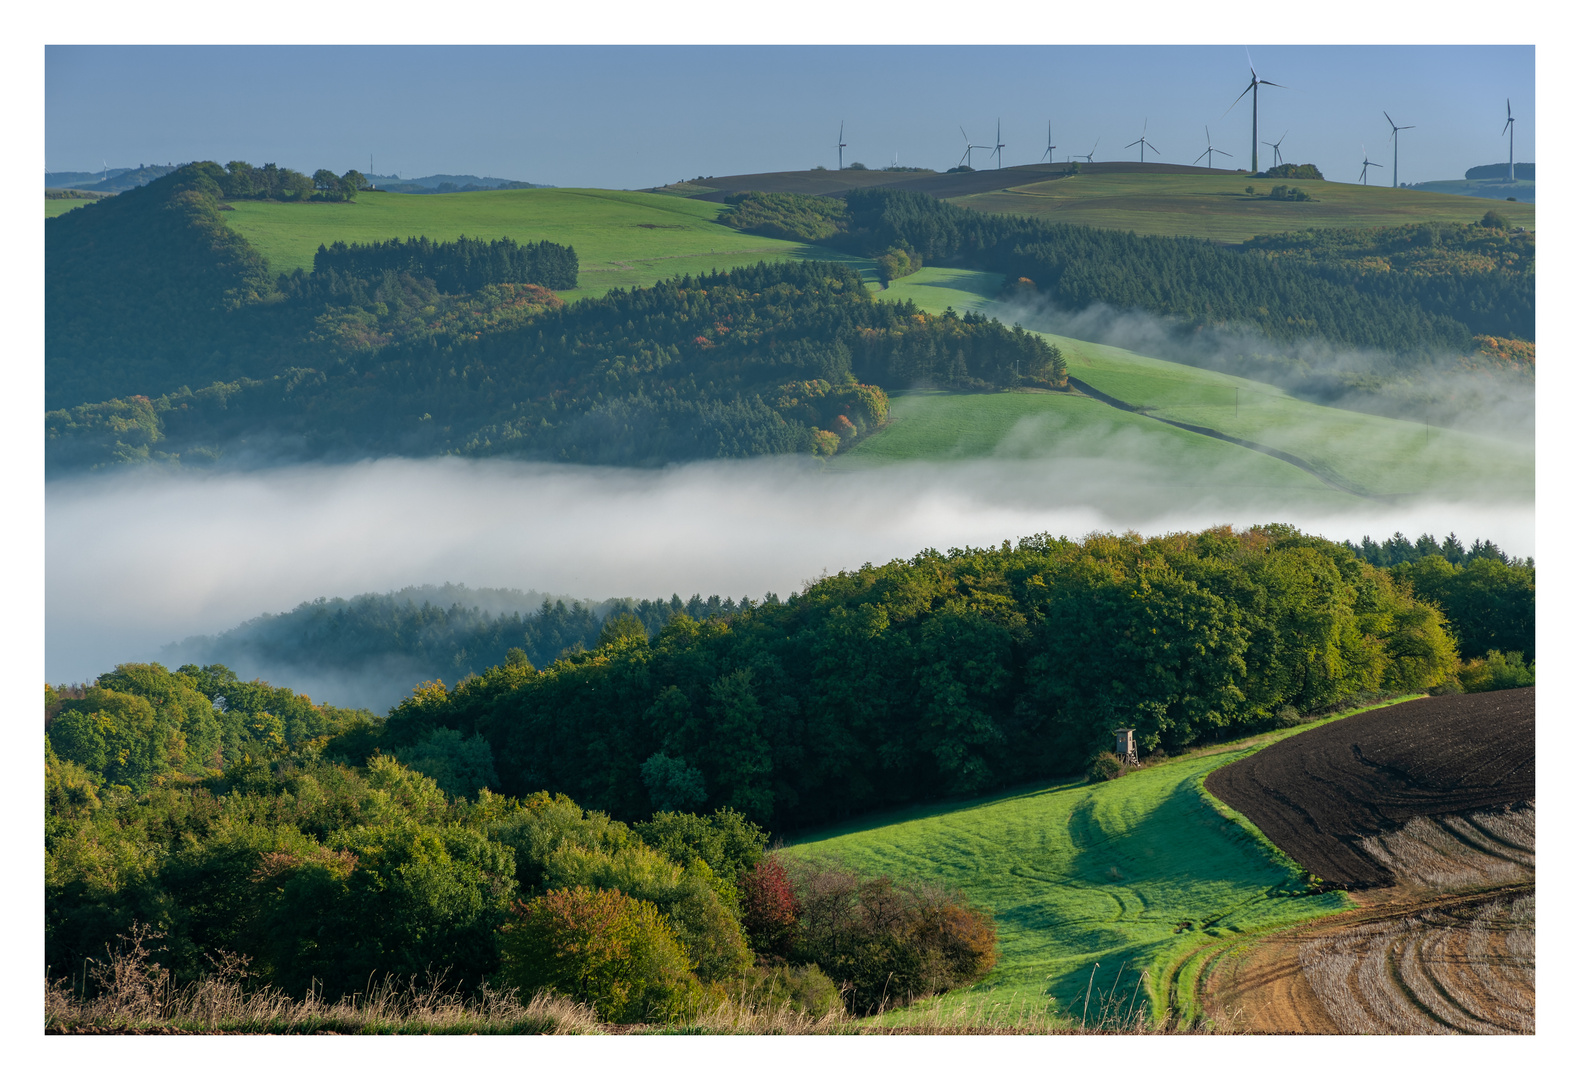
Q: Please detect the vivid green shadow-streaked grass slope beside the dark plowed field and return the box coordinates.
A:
[787,701,1422,1020]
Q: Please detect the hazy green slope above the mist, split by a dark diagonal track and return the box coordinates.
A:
[847,267,1534,496]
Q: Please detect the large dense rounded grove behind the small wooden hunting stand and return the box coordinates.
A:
[346,527,1457,829]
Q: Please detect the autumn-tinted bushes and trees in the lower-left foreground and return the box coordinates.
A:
[44,665,995,1023]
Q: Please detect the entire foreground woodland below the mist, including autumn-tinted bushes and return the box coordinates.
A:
[44,526,1534,1022]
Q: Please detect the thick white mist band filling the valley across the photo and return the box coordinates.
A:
[46,458,1536,701]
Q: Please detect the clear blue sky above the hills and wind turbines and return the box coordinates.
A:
[44,44,1536,188]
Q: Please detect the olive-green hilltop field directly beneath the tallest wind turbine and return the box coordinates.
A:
[950,174,1536,243]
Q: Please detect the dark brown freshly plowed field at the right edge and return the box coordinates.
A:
[1206,687,1536,889]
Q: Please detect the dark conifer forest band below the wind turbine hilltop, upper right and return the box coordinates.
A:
[720,188,1536,355]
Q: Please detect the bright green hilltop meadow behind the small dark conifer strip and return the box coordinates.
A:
[224,188,871,300]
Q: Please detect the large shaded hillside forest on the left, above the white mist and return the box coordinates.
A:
[46,164,1065,469]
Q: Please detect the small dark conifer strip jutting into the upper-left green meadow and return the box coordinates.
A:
[313,237,578,292]
